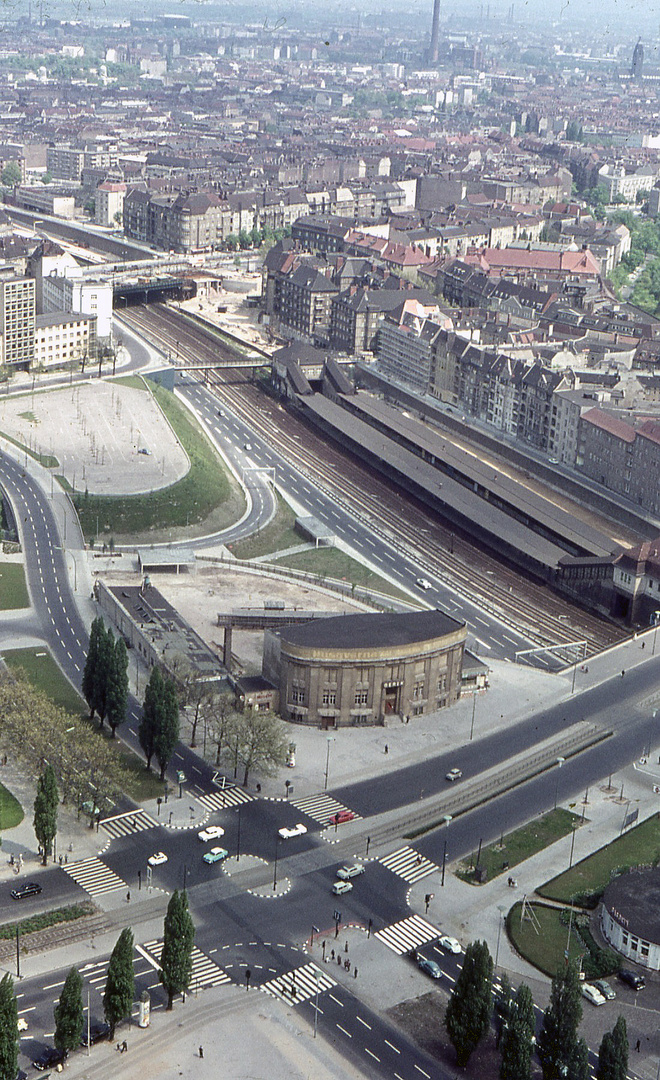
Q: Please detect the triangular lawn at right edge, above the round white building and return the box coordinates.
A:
[537,810,660,906]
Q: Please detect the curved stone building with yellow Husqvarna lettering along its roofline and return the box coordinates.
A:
[264,611,466,728]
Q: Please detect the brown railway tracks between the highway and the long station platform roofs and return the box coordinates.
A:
[122,306,625,660]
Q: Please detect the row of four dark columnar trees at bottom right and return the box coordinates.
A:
[445,941,629,1080]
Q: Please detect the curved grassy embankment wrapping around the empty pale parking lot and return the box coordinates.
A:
[73,386,235,538]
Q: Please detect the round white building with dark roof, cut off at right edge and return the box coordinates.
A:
[601,867,660,971]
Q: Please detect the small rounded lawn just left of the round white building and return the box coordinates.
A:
[507,902,620,978]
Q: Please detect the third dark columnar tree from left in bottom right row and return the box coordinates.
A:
[538,963,582,1080]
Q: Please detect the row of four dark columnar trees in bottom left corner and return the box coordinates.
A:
[0,891,194,1080]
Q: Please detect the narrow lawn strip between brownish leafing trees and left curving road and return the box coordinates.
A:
[2,649,163,803]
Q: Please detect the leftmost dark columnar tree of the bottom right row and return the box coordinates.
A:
[445,942,493,1068]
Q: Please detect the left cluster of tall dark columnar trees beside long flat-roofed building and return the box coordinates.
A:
[82,616,129,738]
